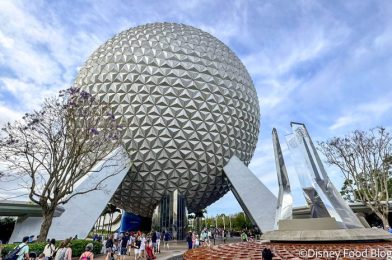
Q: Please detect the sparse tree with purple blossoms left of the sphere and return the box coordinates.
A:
[0,88,121,241]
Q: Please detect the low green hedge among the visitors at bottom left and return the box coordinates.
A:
[1,239,102,257]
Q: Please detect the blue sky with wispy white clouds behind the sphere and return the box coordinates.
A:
[0,0,392,215]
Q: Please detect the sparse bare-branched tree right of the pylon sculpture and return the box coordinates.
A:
[319,127,392,226]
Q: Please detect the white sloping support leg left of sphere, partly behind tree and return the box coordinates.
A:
[10,147,131,242]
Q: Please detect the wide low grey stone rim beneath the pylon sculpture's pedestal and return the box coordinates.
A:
[261,228,392,242]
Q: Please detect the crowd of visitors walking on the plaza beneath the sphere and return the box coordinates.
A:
[4,228,264,260]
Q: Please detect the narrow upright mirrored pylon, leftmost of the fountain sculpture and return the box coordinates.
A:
[272,128,293,229]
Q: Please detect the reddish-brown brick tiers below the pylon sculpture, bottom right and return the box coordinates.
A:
[184,242,392,260]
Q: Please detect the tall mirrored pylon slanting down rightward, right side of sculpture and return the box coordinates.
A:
[289,123,363,228]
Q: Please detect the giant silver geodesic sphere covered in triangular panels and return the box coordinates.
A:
[75,23,260,216]
